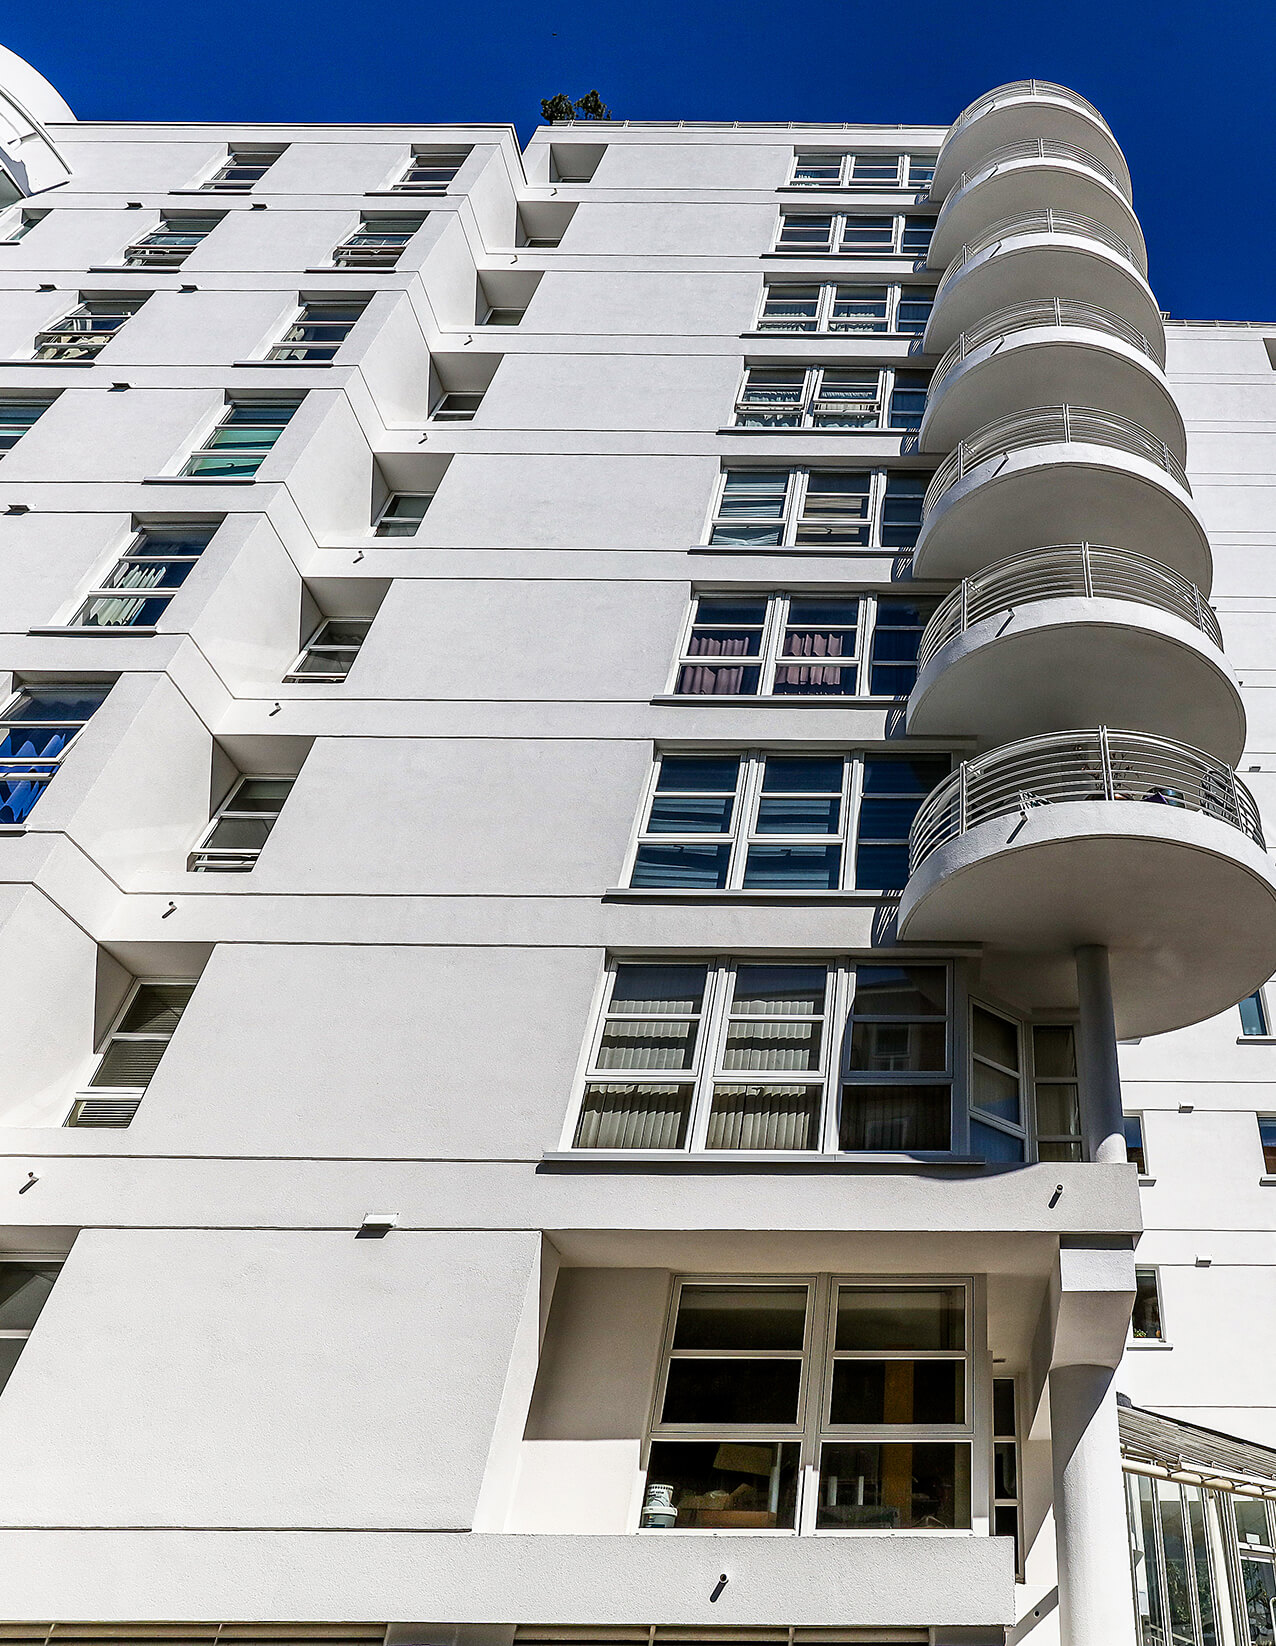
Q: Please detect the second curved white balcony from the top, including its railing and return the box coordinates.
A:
[930,137,1148,273]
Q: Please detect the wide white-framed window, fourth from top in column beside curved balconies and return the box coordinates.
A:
[736,365,930,430]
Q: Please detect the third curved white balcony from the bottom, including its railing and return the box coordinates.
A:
[912,407,1212,591]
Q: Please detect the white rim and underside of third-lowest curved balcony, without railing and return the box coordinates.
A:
[912,443,1212,593]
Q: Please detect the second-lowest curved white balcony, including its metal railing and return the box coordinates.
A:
[909,543,1245,764]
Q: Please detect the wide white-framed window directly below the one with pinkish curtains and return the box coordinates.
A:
[629,752,948,892]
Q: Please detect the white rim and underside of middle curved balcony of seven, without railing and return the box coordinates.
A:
[919,324,1187,463]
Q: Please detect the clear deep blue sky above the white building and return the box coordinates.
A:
[0,0,1276,319]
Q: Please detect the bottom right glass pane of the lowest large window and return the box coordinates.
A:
[815,1442,970,1531]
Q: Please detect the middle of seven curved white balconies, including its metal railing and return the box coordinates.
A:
[919,298,1187,463]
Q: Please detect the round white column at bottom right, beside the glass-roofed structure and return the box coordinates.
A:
[1050,1366,1136,1646]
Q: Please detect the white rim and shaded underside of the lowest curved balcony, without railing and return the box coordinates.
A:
[899,800,1276,1039]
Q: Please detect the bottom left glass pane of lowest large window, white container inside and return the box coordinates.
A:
[642,1440,799,1531]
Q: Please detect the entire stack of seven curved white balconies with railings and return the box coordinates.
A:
[899,81,1276,1035]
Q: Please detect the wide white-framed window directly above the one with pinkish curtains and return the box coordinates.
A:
[710,469,929,550]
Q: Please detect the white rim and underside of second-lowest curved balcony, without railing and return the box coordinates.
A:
[909,597,1245,765]
